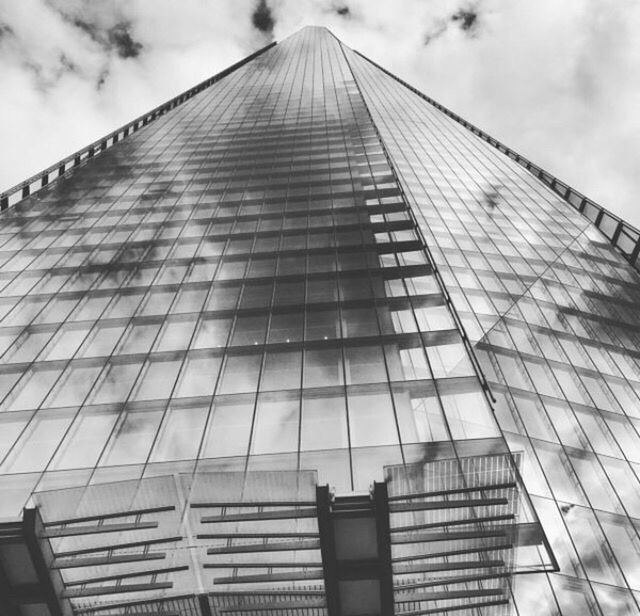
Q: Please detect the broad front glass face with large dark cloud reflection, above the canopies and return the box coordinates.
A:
[0,28,498,516]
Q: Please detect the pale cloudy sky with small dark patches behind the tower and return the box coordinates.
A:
[0,0,640,227]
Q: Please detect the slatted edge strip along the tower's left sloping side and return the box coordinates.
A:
[0,41,277,210]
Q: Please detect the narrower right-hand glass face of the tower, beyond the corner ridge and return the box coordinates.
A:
[345,42,640,616]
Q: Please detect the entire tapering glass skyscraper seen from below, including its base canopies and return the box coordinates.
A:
[0,28,640,616]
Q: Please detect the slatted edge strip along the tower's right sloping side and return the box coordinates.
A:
[353,49,640,271]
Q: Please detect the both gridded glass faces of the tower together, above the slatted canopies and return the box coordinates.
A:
[0,28,640,616]
